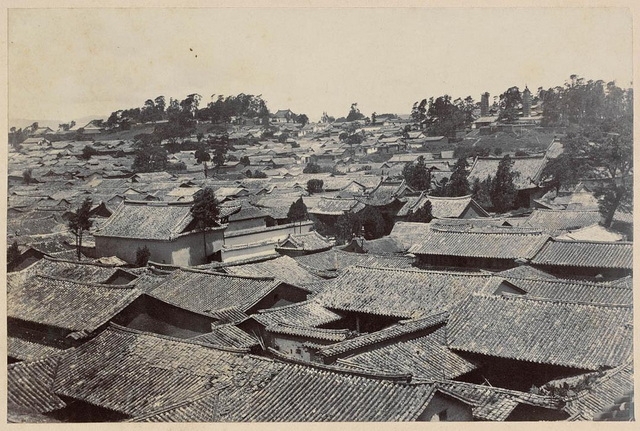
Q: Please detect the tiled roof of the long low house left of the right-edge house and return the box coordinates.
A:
[409,227,549,259]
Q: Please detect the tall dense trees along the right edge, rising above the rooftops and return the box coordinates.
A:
[539,75,633,226]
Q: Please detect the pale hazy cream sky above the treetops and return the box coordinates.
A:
[8,8,632,121]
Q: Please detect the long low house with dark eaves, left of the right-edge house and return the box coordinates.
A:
[409,226,549,270]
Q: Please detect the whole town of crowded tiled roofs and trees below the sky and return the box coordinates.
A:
[7,76,633,422]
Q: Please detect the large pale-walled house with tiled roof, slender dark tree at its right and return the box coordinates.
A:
[93,201,226,266]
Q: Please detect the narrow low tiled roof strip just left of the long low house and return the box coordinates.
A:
[294,249,413,271]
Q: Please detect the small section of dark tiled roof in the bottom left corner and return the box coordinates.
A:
[7,355,66,413]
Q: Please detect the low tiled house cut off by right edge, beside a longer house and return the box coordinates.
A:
[531,239,633,279]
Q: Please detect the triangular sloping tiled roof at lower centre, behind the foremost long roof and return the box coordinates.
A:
[337,326,476,379]
